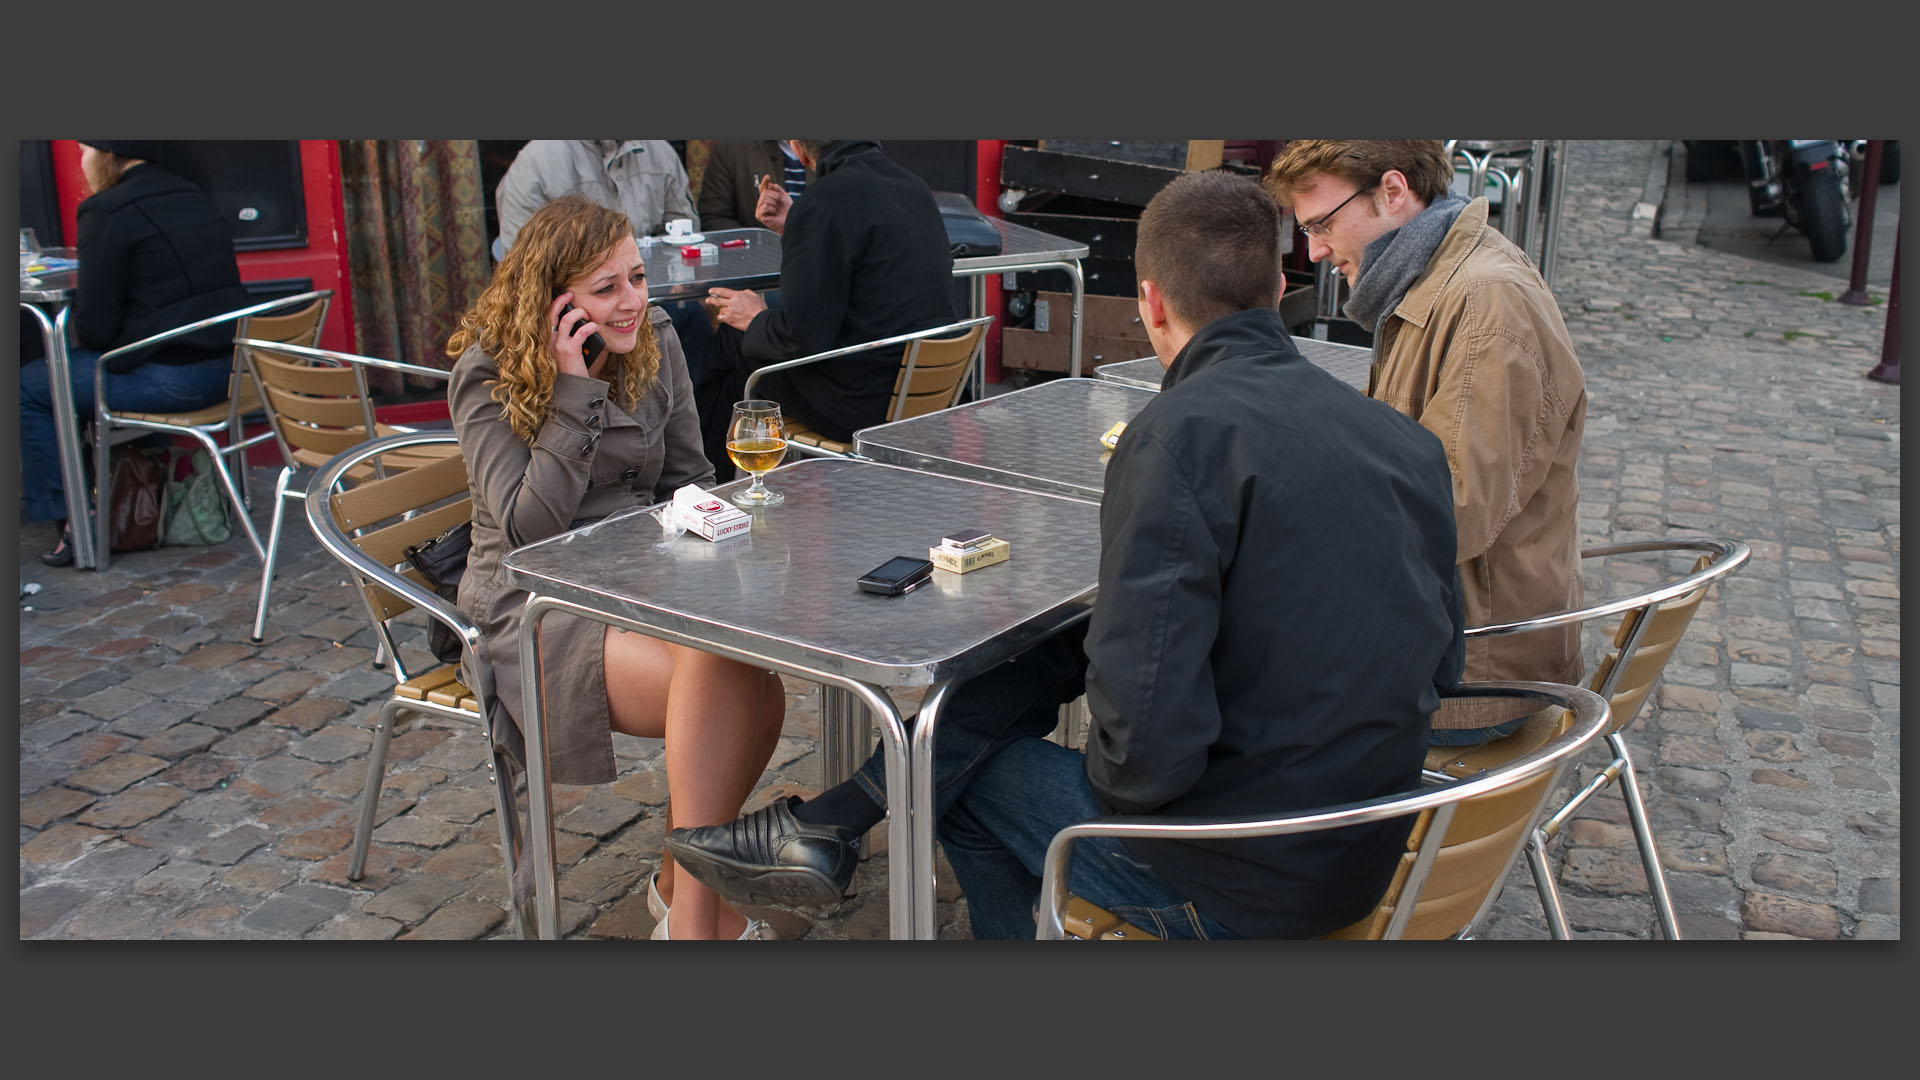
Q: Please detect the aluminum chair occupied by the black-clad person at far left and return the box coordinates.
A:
[94,288,334,571]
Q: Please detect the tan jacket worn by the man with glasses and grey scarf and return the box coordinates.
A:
[1367,198,1586,728]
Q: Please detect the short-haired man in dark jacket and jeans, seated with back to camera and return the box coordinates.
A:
[668,171,1465,938]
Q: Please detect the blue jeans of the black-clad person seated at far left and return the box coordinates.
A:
[19,348,234,521]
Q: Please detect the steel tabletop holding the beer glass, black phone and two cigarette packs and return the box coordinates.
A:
[505,453,1100,686]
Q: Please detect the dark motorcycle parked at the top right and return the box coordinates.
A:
[1688,138,1853,263]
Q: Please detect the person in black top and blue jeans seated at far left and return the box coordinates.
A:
[19,140,248,567]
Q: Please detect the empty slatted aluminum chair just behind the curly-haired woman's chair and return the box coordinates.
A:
[234,338,459,644]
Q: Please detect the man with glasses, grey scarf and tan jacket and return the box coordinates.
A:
[1267,140,1586,746]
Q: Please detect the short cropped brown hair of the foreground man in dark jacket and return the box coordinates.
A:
[1133,169,1281,331]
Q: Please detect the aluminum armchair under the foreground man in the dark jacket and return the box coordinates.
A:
[1037,682,1609,942]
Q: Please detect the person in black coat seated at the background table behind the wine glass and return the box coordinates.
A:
[693,138,954,480]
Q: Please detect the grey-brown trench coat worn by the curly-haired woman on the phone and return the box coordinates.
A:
[447,307,714,784]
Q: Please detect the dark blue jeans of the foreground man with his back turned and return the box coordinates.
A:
[854,623,1236,940]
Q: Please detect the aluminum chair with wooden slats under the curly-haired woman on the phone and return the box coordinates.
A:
[305,432,532,938]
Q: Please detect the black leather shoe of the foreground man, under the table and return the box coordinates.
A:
[666,796,860,907]
